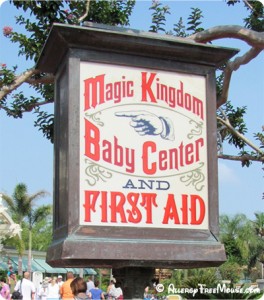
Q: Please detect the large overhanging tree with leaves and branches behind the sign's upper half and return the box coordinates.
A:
[0,0,264,166]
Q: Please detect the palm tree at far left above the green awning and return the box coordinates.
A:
[3,183,50,274]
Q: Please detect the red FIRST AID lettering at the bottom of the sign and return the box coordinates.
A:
[83,190,206,227]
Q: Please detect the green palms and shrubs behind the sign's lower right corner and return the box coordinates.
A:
[159,213,264,299]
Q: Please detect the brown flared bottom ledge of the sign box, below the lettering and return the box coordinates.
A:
[44,236,226,269]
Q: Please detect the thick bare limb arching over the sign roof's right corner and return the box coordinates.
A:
[188,25,264,49]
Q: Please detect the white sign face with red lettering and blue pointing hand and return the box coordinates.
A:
[80,62,208,229]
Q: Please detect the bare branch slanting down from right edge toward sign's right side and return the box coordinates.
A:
[217,48,262,108]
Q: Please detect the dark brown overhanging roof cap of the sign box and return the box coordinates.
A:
[36,22,239,74]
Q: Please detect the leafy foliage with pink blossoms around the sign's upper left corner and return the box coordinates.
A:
[0,0,135,142]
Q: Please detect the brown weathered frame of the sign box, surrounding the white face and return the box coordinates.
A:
[37,23,238,268]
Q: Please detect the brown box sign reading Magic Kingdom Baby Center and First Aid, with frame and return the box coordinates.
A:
[37,23,237,268]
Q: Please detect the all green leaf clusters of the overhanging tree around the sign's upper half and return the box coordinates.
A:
[0,0,264,166]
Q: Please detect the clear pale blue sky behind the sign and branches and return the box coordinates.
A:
[0,0,264,220]
